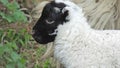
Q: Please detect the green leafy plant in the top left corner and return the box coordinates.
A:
[0,0,27,23]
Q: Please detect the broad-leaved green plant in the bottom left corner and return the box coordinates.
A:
[0,42,25,68]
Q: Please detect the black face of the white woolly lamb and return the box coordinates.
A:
[33,1,67,44]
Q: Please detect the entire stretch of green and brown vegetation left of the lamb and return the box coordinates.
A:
[0,0,55,68]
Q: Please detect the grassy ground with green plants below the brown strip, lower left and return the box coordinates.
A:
[0,24,55,68]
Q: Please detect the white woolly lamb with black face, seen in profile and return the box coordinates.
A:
[33,1,120,68]
